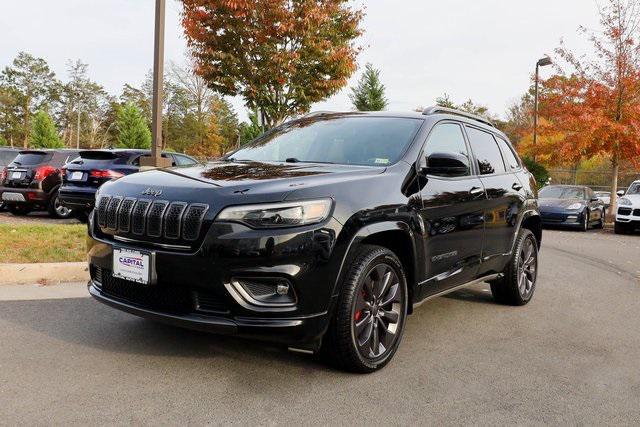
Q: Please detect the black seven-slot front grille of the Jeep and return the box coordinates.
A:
[96,196,209,240]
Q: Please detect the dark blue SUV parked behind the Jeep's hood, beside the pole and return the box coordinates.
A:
[60,149,198,218]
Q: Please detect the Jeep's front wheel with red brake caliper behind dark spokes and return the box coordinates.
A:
[322,245,408,373]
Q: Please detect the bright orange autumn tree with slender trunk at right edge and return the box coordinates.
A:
[540,0,640,214]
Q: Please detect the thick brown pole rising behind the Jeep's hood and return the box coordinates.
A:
[140,0,171,168]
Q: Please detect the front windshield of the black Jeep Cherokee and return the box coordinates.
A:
[230,116,422,166]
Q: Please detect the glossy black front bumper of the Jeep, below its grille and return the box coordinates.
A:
[88,218,343,350]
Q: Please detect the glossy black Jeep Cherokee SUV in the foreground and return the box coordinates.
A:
[89,107,542,372]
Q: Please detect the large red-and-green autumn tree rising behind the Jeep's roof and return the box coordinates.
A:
[183,0,363,127]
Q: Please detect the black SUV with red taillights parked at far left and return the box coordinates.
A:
[0,150,78,218]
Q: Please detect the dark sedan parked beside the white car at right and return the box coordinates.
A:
[538,185,605,231]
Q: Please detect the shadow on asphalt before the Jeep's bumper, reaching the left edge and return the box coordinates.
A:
[0,298,338,370]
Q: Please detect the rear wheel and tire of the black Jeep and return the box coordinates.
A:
[491,228,538,305]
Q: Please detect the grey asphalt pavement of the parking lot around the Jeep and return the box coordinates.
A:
[0,231,640,425]
